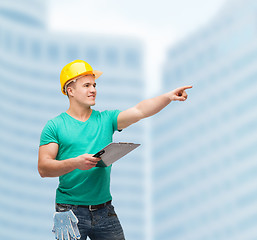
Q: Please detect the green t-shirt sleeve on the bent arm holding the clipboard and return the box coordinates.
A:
[39,120,59,146]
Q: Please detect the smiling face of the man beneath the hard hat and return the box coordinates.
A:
[67,75,96,107]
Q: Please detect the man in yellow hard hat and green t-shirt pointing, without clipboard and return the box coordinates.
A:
[38,60,192,240]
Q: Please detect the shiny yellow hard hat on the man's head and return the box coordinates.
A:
[60,60,103,95]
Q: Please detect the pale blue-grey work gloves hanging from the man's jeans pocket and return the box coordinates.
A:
[52,210,80,240]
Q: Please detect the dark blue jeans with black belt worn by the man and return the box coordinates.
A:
[56,204,125,240]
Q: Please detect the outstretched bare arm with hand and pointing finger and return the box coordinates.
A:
[118,86,192,130]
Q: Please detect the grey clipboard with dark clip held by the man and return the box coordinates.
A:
[93,142,141,167]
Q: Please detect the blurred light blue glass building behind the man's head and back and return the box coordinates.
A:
[0,0,145,240]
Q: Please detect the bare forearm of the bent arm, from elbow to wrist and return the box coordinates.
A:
[38,158,76,177]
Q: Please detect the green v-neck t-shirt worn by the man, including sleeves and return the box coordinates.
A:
[40,110,120,205]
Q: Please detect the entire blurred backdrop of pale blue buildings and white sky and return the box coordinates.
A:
[0,0,257,240]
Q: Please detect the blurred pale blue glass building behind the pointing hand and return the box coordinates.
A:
[152,1,257,240]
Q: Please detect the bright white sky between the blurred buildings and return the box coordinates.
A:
[48,0,227,94]
